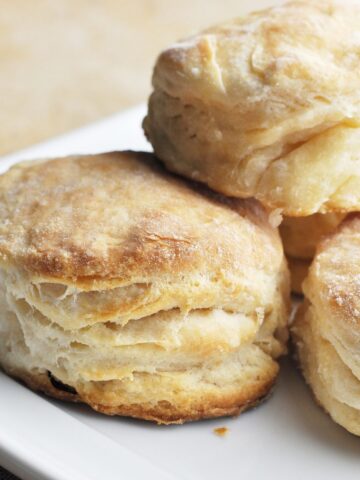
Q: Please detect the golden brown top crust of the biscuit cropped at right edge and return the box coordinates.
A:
[304,214,360,329]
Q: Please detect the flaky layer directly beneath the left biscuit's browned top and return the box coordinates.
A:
[0,259,287,330]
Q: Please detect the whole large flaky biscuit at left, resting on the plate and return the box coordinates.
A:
[0,152,288,423]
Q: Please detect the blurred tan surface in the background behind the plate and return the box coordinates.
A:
[0,0,280,154]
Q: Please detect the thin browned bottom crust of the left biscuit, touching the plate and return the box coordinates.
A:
[5,362,278,425]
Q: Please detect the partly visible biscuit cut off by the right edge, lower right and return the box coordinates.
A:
[292,214,360,435]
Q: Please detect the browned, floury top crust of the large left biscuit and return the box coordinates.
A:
[0,152,282,283]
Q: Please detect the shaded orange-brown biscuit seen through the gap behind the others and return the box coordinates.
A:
[279,213,345,294]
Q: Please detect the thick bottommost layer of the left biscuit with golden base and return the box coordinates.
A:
[4,352,279,424]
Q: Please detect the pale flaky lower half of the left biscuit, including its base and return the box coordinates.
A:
[0,270,287,423]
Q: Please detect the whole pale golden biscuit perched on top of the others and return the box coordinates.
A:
[144,1,360,216]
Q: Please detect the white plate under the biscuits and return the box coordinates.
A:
[0,107,360,480]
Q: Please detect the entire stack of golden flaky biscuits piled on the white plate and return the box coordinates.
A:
[0,0,360,434]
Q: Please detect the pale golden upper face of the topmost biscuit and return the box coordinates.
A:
[154,1,360,124]
